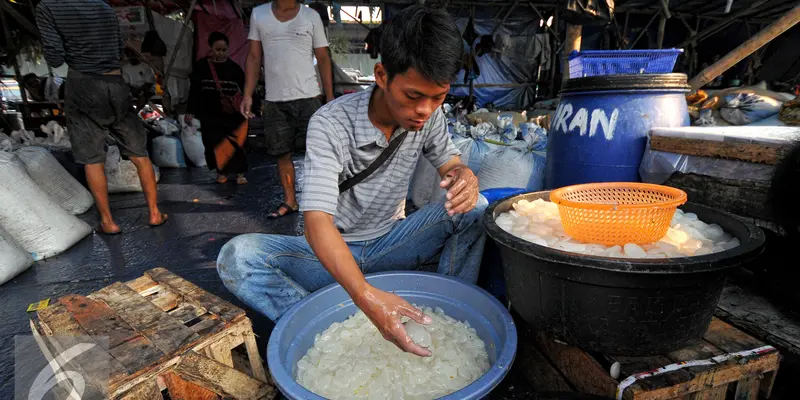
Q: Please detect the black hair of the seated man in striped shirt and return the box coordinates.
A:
[380,5,464,84]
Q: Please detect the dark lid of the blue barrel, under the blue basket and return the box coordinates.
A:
[561,74,690,93]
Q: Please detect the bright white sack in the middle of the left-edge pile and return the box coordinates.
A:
[0,152,92,260]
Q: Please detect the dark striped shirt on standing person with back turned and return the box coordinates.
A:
[36,0,124,74]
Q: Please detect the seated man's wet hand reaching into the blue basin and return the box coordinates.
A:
[353,286,432,357]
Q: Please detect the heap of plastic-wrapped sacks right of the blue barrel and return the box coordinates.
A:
[686,82,795,126]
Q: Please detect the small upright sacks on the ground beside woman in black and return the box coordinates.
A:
[150,115,206,168]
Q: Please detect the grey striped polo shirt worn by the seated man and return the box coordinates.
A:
[300,86,460,242]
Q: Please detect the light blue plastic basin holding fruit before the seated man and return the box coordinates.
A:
[267,272,517,400]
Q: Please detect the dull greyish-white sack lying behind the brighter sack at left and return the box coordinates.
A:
[14,146,94,214]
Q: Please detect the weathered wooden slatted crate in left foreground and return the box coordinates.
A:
[31,268,276,400]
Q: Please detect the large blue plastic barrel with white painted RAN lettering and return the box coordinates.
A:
[544,74,690,189]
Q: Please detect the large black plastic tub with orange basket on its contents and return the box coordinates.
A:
[484,191,764,356]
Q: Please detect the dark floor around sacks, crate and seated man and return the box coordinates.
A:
[0,155,544,399]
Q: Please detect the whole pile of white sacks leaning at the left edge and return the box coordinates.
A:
[0,146,93,284]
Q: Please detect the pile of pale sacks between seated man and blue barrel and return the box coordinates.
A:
[409,114,547,207]
